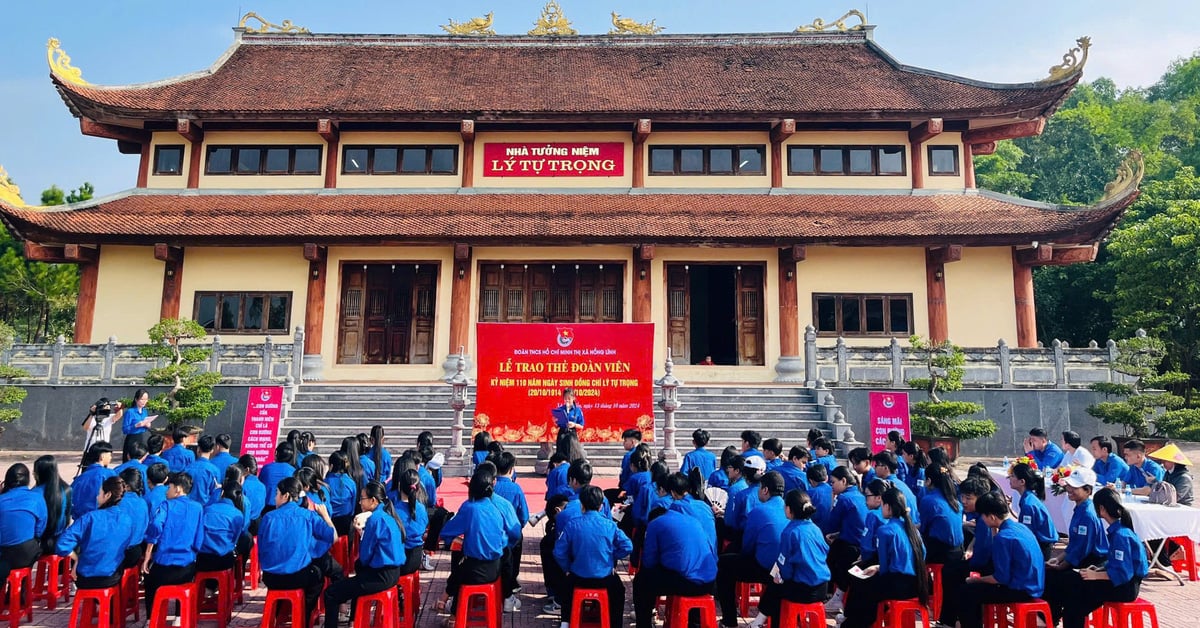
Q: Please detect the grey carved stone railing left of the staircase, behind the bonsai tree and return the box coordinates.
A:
[0,327,304,384]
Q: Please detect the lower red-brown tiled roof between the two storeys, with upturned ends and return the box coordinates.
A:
[0,187,1138,245]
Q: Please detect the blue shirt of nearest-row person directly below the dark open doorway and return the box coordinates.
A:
[643,509,716,585]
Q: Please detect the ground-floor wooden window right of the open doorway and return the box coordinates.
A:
[812,294,912,336]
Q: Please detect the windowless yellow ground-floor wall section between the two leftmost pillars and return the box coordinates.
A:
[91,244,163,343]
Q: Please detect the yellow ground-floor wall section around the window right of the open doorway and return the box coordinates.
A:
[796,246,926,346]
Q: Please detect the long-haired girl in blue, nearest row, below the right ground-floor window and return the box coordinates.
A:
[842,484,929,628]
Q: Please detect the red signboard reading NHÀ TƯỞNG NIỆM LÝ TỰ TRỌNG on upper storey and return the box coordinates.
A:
[484,142,625,177]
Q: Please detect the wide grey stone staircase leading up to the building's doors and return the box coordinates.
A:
[281,383,833,474]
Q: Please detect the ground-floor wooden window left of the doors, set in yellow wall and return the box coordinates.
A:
[192,292,292,334]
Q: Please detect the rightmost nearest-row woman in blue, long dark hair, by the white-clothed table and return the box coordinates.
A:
[1062,488,1150,628]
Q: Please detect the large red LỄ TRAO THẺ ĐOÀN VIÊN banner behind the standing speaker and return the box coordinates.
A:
[475,323,654,443]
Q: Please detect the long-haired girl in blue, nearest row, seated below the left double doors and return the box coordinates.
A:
[325,482,407,628]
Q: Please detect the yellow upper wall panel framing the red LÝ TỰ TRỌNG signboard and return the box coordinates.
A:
[474,131,633,187]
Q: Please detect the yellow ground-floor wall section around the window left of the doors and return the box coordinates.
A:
[178,245,308,345]
